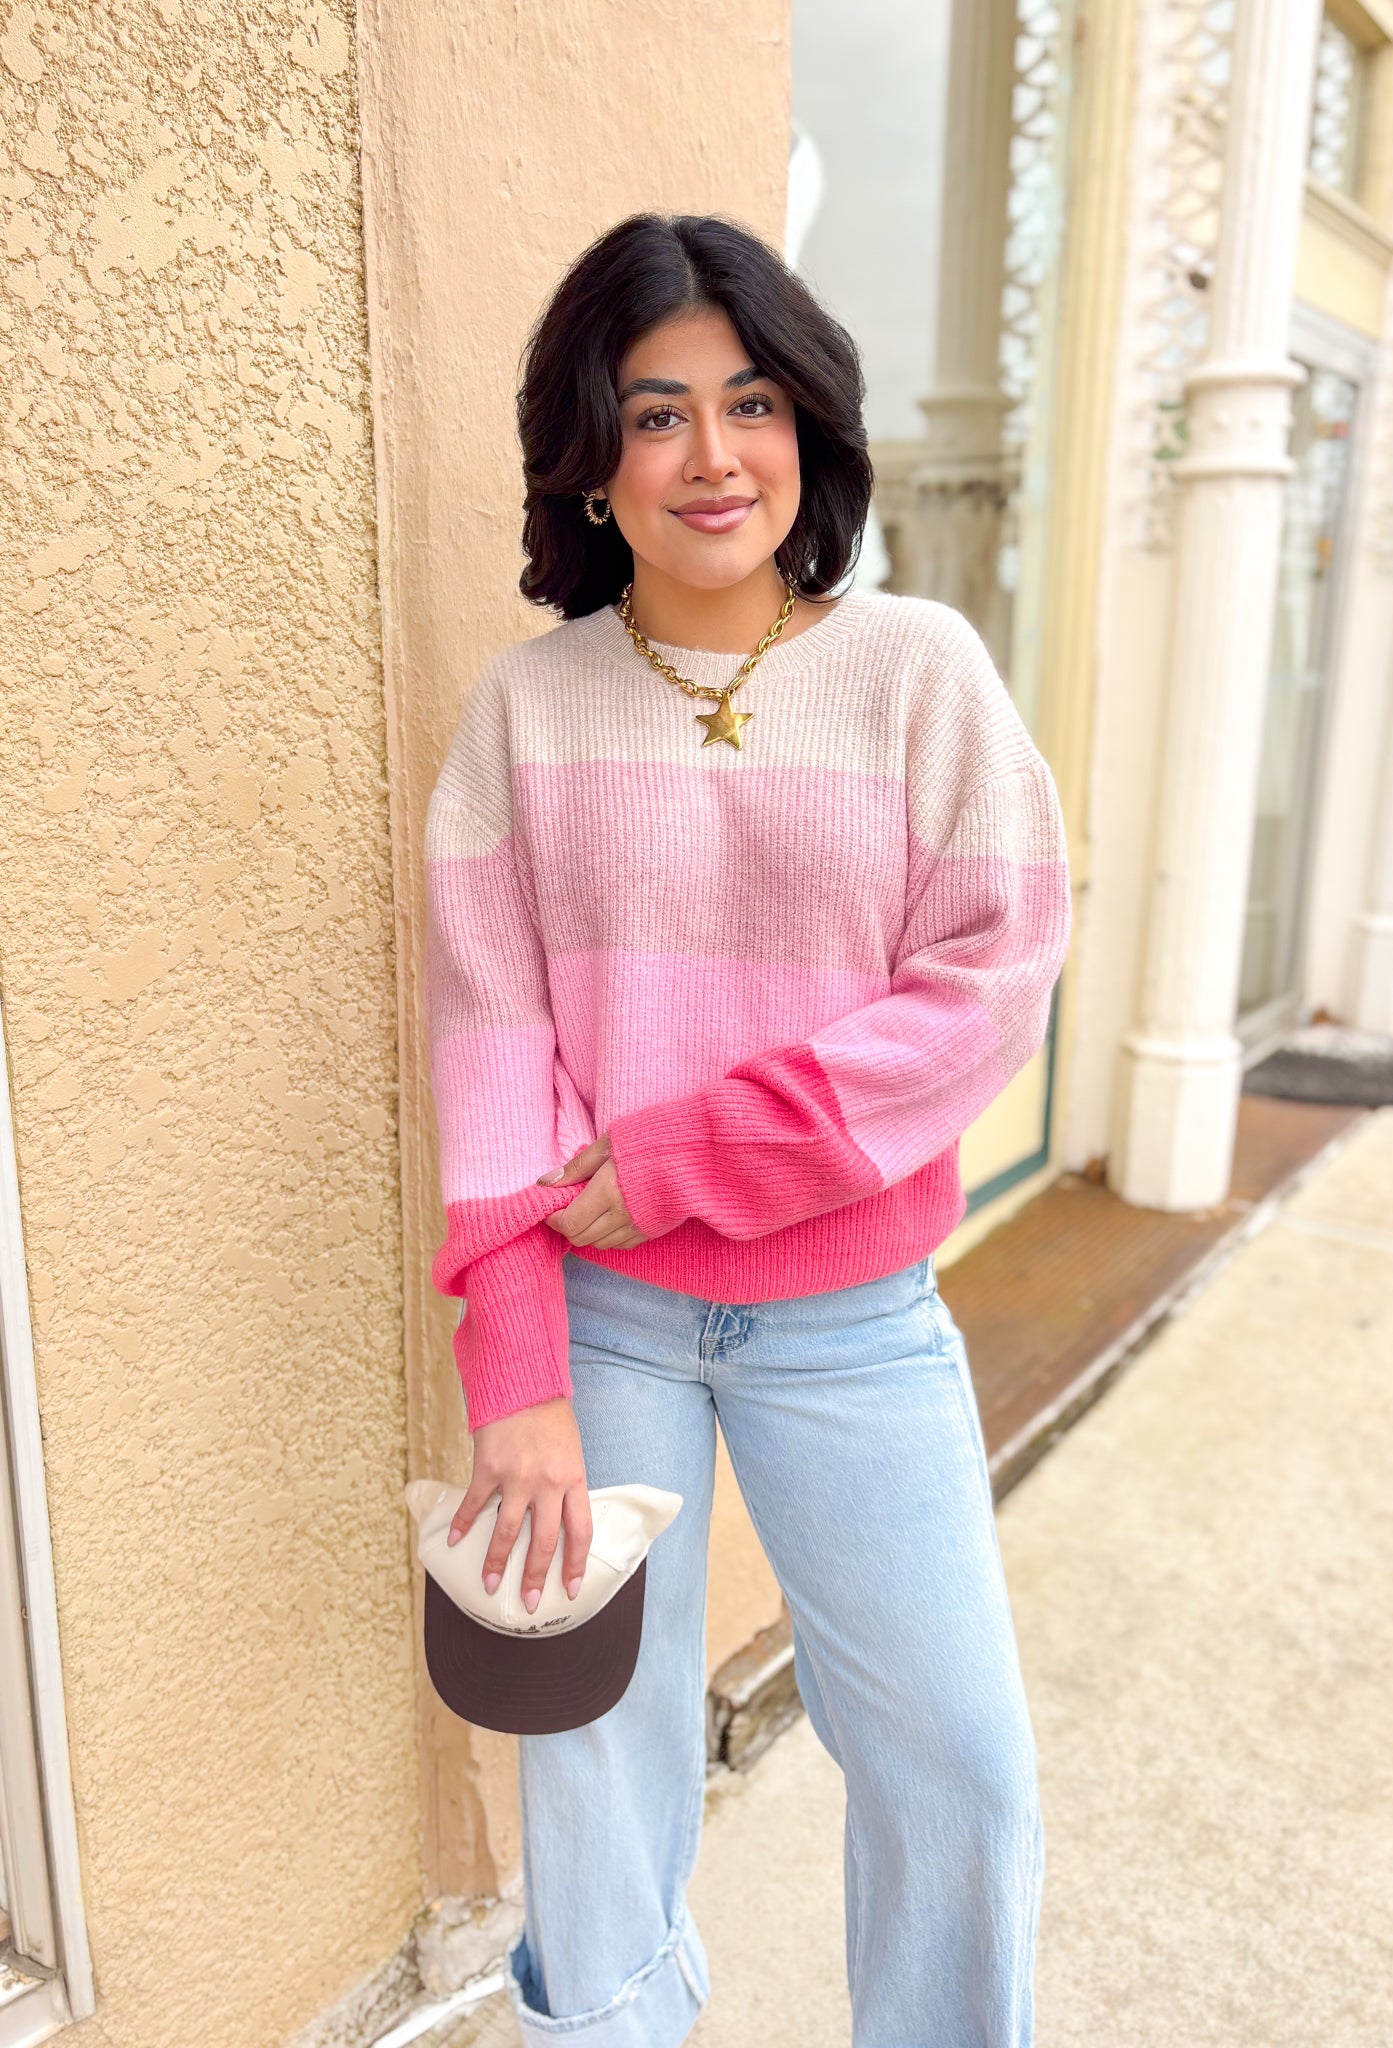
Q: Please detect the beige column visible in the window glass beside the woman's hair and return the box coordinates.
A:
[899,0,1016,666]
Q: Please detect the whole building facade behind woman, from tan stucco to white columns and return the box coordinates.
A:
[0,0,1393,2048]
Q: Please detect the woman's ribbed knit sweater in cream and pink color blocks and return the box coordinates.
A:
[426,590,1069,1430]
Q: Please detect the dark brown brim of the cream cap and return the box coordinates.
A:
[424,1559,647,1735]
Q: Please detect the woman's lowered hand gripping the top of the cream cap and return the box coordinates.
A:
[447,1395,592,1614]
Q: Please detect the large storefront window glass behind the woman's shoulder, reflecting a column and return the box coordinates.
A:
[787,0,1073,1208]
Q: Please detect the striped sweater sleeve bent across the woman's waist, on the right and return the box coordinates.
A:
[608,612,1071,1239]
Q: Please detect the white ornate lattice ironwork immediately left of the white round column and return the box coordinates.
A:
[1133,0,1233,547]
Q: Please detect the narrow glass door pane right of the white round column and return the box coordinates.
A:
[1237,338,1360,1047]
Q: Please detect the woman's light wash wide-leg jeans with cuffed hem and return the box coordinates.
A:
[508,1253,1043,2048]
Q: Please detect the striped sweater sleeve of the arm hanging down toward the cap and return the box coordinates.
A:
[426,664,594,1430]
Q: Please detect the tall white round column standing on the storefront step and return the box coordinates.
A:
[1108,0,1321,1208]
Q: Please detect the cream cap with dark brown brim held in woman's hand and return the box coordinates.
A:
[406,1479,682,1735]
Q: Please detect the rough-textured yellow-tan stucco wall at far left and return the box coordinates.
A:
[0,0,420,2048]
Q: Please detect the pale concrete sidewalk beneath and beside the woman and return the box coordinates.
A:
[455,1110,1393,2048]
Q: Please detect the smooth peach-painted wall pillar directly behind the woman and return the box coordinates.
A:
[361,0,789,1892]
